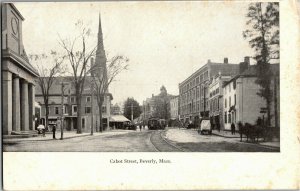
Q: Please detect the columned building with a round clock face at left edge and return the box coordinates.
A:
[1,3,38,135]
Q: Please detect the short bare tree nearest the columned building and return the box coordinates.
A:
[29,51,65,131]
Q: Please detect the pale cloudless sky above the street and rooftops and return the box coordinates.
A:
[14,1,254,104]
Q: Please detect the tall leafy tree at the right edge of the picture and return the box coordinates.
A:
[243,2,279,126]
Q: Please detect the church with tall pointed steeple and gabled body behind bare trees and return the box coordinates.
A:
[36,13,113,132]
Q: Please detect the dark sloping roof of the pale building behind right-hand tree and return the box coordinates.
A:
[223,64,279,87]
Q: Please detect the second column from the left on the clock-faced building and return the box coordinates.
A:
[12,75,21,131]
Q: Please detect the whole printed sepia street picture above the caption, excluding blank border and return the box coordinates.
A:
[2,2,280,152]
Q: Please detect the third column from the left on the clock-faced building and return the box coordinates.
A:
[21,80,29,131]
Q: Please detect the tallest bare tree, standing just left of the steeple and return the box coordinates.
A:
[59,21,96,133]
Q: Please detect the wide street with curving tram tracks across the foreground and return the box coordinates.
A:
[3,128,279,152]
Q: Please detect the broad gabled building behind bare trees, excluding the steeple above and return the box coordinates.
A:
[36,76,112,132]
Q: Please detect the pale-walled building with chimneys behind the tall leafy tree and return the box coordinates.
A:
[223,62,280,130]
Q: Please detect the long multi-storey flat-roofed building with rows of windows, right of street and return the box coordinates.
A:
[179,58,239,124]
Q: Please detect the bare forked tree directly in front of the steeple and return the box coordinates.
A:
[91,56,129,132]
